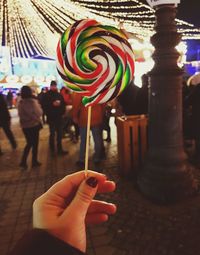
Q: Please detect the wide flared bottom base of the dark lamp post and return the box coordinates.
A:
[138,162,197,204]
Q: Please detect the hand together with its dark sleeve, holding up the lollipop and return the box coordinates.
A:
[10,171,116,255]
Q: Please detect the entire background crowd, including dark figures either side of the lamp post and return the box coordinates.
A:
[0,74,200,169]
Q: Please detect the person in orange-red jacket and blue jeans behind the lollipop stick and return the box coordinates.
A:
[73,93,104,167]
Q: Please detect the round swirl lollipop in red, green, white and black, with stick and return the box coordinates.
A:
[57,19,134,173]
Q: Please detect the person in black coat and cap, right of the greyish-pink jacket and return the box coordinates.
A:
[42,81,68,155]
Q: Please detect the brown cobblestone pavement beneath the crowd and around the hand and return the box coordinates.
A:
[0,110,200,255]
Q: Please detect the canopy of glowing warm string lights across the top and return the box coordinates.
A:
[0,0,200,58]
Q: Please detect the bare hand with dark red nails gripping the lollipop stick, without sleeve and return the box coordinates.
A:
[33,171,116,252]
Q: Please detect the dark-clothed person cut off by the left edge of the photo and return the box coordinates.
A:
[0,93,17,149]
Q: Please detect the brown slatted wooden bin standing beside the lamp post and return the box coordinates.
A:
[116,115,147,175]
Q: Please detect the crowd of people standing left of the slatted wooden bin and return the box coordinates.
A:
[0,81,115,169]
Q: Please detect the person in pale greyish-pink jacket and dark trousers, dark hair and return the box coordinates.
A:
[18,86,42,169]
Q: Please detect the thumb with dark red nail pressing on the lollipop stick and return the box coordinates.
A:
[68,177,98,217]
